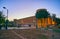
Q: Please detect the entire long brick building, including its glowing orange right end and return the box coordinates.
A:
[14,16,56,28]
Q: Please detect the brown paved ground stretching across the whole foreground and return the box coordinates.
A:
[0,29,60,39]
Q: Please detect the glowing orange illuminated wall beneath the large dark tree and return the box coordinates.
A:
[37,17,56,28]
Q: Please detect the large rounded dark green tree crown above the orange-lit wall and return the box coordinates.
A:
[35,9,50,27]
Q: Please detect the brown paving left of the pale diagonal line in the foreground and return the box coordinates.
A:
[0,30,21,39]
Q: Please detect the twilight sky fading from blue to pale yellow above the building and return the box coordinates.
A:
[0,0,60,20]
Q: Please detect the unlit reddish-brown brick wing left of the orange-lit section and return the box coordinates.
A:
[14,16,36,27]
